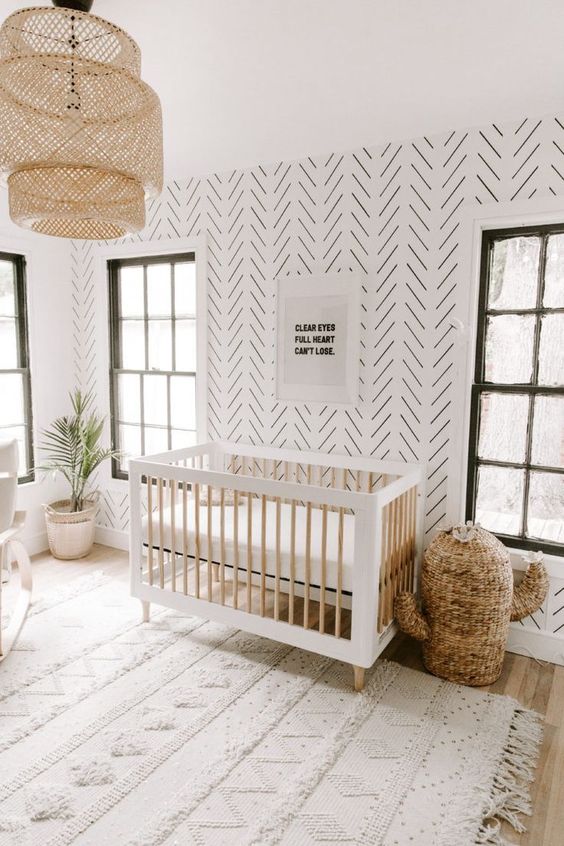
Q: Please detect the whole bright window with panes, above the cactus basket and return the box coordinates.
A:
[467,226,564,553]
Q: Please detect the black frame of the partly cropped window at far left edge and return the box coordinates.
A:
[0,252,35,485]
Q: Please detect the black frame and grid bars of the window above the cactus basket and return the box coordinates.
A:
[466,223,564,556]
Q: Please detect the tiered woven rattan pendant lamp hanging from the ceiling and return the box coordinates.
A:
[0,0,163,240]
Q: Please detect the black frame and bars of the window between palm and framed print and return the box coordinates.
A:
[107,250,199,481]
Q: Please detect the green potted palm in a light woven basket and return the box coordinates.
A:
[38,389,118,559]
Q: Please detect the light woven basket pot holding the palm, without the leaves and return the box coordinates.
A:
[43,496,98,561]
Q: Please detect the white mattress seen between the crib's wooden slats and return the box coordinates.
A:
[142,498,354,593]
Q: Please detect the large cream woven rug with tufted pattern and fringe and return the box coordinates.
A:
[0,575,541,846]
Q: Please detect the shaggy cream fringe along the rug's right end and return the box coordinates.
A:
[474,708,543,846]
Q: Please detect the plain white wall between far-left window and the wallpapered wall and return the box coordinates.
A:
[0,190,76,554]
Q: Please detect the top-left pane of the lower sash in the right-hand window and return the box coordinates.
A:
[478,393,529,463]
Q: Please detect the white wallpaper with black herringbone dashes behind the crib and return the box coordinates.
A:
[73,112,564,640]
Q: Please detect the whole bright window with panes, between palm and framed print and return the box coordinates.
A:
[108,253,196,478]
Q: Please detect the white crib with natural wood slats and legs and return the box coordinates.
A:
[129,442,425,689]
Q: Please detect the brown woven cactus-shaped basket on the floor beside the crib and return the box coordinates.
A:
[395,527,548,685]
